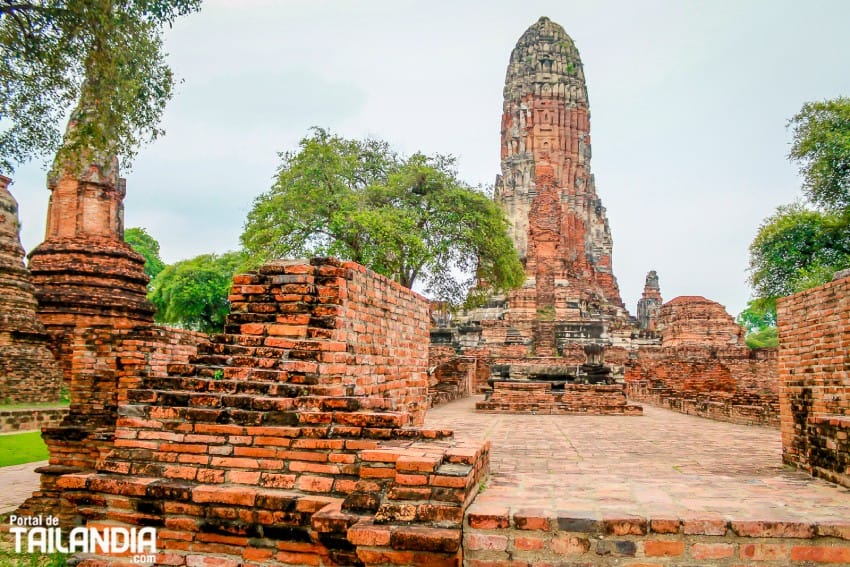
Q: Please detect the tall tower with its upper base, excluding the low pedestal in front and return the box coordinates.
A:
[450,18,629,372]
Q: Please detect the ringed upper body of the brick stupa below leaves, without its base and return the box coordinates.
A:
[29,158,154,381]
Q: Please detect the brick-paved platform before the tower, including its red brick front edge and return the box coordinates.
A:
[426,398,850,567]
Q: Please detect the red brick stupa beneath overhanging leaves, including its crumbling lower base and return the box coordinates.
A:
[18,151,161,521]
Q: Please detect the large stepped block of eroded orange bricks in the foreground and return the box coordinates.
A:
[39,259,488,566]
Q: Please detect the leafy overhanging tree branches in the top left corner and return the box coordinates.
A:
[0,0,201,173]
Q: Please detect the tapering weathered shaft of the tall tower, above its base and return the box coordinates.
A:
[496,17,623,308]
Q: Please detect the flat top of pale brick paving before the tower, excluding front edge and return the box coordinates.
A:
[426,398,850,523]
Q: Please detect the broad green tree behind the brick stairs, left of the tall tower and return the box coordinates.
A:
[242,128,524,304]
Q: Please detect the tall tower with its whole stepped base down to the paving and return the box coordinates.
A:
[433,18,640,414]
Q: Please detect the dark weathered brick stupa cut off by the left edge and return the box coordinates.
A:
[0,175,62,404]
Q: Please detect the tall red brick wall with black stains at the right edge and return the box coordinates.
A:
[777,277,850,486]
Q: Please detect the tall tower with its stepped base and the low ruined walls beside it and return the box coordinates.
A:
[424,18,778,424]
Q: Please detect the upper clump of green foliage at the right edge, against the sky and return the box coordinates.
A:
[789,97,850,211]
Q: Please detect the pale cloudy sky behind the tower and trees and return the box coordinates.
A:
[6,0,850,314]
